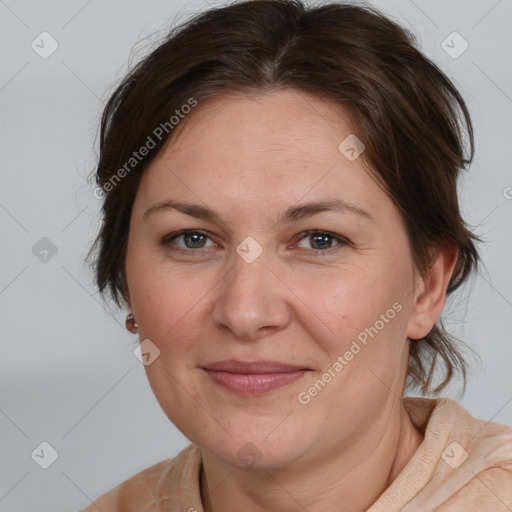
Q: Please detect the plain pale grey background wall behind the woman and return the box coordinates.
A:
[0,0,512,512]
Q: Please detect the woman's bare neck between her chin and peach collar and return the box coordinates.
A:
[200,402,423,512]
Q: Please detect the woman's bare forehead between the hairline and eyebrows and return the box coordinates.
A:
[132,90,392,224]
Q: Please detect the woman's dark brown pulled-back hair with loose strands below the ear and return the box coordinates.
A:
[87,0,479,394]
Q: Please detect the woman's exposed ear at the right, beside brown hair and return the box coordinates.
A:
[407,241,458,340]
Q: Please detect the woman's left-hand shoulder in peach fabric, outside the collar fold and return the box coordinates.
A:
[80,444,197,512]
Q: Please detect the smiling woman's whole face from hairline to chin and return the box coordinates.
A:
[126,90,428,468]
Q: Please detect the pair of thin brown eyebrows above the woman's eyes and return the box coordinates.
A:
[142,199,374,224]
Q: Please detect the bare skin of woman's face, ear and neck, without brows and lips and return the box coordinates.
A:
[126,90,456,512]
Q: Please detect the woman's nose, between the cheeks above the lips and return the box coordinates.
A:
[213,246,292,341]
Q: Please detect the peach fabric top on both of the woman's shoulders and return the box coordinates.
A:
[81,397,512,512]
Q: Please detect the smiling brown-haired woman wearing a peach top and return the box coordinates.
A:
[81,0,512,512]
